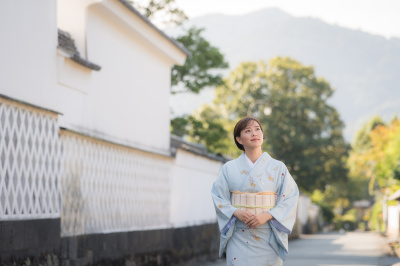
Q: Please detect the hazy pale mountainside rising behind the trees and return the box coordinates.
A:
[167,8,400,141]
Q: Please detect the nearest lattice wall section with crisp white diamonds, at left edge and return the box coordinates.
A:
[0,97,61,220]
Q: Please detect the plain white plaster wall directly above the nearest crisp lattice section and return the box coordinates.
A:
[0,0,58,111]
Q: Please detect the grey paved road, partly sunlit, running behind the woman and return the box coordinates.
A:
[195,232,400,266]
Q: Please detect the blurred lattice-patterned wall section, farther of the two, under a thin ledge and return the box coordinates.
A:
[61,131,172,236]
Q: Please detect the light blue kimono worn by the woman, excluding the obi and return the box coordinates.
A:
[211,153,299,266]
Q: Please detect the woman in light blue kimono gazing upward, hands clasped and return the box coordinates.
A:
[211,117,299,266]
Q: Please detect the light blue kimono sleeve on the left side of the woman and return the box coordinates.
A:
[211,164,237,234]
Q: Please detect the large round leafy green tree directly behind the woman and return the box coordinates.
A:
[202,57,348,191]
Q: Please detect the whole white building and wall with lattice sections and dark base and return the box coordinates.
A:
[0,0,224,265]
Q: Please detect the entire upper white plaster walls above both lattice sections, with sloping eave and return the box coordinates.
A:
[0,0,186,154]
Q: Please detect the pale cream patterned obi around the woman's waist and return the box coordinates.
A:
[232,190,277,214]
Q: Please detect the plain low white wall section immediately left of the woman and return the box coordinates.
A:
[170,149,222,227]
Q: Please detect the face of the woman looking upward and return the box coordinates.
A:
[236,120,264,150]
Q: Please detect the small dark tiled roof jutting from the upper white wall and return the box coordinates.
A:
[58,29,101,71]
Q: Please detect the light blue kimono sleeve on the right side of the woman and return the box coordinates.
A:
[268,165,299,260]
